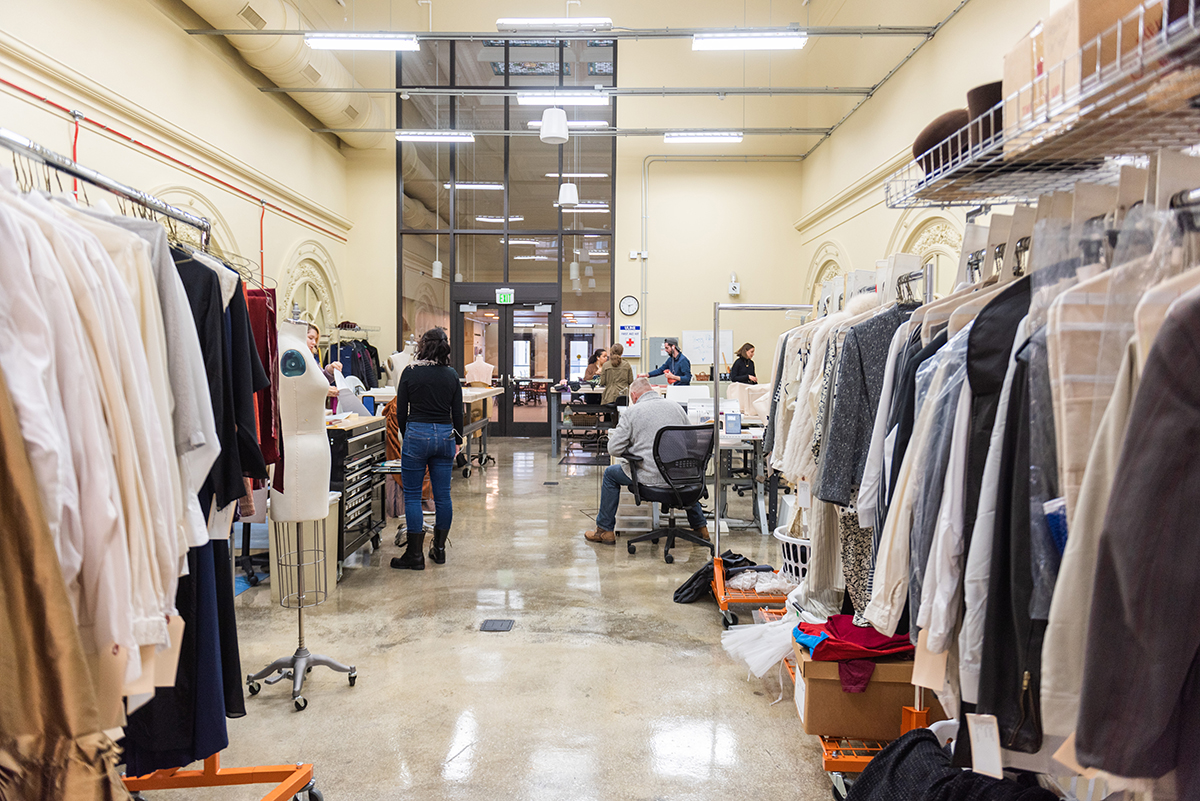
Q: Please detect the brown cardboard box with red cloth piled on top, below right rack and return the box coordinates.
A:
[792,643,946,740]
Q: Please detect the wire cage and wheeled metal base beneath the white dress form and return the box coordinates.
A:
[246,520,359,712]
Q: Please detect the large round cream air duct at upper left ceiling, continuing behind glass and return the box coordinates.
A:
[184,0,451,228]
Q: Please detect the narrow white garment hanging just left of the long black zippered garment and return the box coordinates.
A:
[959,314,1028,704]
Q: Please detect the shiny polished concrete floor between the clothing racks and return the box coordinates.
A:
[171,439,830,801]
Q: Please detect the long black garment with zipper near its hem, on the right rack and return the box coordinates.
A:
[978,335,1045,753]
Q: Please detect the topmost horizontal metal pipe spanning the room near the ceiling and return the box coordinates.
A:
[187,25,938,42]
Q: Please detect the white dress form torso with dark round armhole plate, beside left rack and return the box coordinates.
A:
[271,320,330,523]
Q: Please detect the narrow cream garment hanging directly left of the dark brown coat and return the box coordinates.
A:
[1042,338,1139,737]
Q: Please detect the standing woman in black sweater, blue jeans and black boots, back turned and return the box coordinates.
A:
[391,329,462,570]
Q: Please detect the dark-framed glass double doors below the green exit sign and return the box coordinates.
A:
[451,302,562,436]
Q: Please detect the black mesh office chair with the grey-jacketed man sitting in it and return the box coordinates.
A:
[624,426,716,565]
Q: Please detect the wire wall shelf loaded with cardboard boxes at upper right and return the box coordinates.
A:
[884,0,1200,209]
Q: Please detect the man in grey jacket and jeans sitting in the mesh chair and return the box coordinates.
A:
[583,378,708,544]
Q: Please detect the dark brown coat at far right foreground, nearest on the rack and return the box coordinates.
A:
[1075,299,1200,799]
